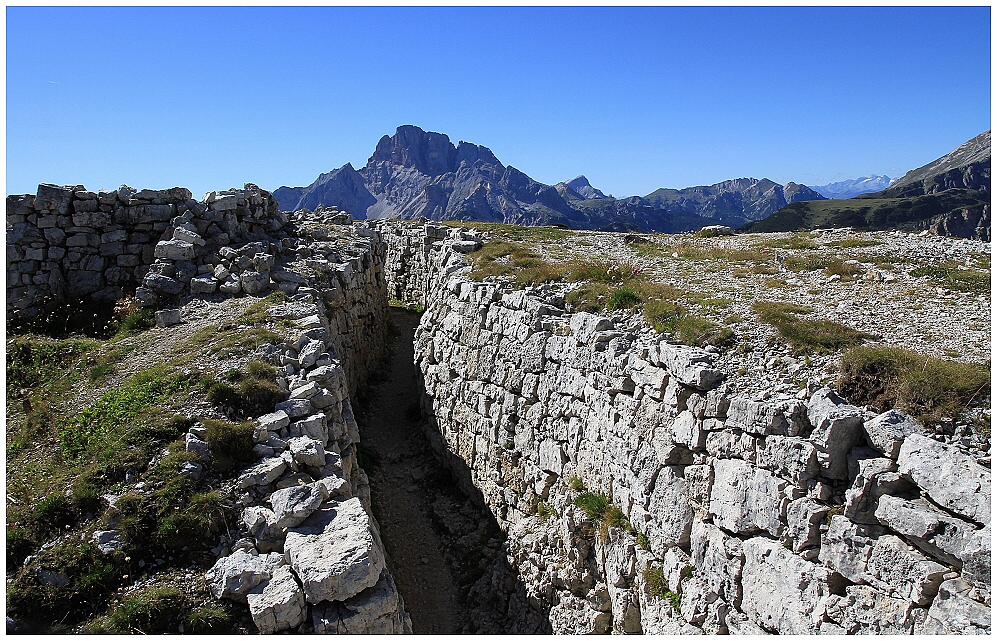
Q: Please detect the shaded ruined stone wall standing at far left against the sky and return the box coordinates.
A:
[7,184,287,318]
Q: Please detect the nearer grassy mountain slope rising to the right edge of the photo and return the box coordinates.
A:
[741,130,990,242]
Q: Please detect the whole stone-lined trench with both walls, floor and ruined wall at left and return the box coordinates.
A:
[7,185,991,634]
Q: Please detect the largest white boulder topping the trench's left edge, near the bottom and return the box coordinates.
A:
[284,498,384,603]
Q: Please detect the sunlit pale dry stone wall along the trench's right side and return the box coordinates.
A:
[379,222,991,634]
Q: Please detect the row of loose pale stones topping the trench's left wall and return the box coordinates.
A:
[197,258,411,634]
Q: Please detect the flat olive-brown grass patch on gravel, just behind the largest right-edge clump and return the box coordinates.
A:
[751,301,871,353]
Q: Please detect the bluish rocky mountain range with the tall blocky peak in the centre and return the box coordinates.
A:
[273,125,824,232]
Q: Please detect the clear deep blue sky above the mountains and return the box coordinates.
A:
[7,7,991,197]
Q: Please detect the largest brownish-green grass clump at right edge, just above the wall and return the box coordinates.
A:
[838,347,990,423]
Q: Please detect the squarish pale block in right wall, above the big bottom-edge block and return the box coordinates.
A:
[710,460,787,537]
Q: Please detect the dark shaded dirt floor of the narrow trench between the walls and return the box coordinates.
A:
[358,308,519,634]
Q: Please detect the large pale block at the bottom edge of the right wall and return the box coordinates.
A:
[741,537,830,634]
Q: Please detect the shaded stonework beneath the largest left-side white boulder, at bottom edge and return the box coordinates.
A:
[312,570,412,634]
